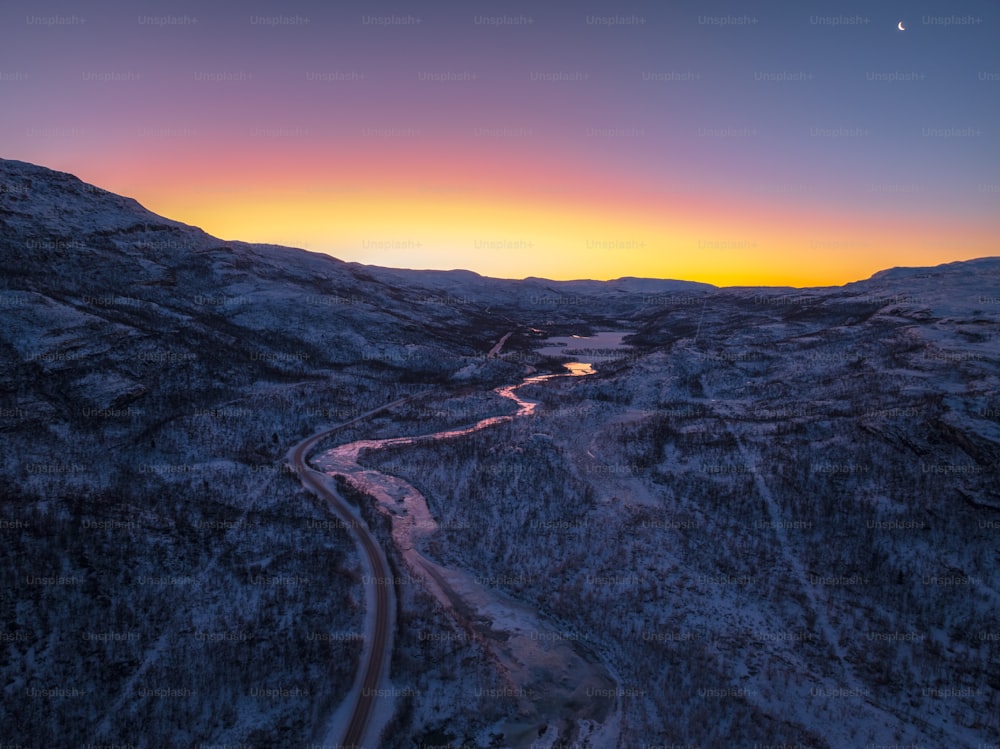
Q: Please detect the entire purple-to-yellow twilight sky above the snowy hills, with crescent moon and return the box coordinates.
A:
[0,0,1000,286]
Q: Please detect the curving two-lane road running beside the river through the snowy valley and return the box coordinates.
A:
[289,396,414,747]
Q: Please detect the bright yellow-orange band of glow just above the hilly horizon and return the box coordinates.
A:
[131,181,995,287]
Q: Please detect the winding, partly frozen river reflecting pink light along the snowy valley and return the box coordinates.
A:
[310,338,620,747]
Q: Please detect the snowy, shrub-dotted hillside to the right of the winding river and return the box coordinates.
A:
[366,258,1000,749]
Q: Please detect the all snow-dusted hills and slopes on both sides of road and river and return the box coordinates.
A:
[0,160,1000,747]
